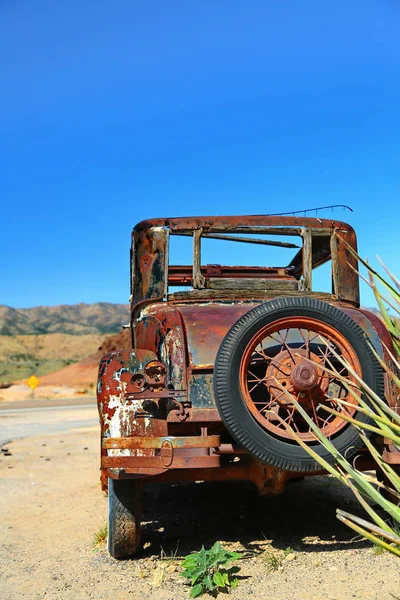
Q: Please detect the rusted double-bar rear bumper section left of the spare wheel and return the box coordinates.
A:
[101,435,221,476]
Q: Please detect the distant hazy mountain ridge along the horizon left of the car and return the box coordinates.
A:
[0,302,129,335]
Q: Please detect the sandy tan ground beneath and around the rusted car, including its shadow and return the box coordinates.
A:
[0,427,400,600]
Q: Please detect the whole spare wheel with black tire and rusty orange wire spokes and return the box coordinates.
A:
[214,297,384,472]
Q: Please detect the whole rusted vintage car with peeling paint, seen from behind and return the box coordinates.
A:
[98,216,400,557]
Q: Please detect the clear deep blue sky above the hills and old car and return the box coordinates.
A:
[0,0,400,307]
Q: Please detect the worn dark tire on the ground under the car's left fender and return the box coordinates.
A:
[108,479,142,558]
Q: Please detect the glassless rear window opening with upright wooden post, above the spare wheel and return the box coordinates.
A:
[168,228,318,293]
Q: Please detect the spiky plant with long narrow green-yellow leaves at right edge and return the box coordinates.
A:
[277,238,400,557]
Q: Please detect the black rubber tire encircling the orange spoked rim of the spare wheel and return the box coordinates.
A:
[214,297,384,472]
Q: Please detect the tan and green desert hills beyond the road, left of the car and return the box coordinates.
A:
[0,302,129,384]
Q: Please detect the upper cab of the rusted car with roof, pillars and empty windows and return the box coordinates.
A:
[131,215,359,304]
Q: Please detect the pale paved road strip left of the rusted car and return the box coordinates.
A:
[0,398,98,446]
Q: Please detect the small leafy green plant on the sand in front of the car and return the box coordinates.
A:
[181,542,242,598]
